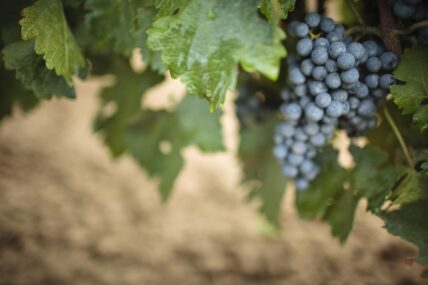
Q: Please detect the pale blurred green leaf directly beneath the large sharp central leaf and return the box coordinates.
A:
[177,96,224,152]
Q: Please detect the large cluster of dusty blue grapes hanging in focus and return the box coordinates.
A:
[273,13,398,190]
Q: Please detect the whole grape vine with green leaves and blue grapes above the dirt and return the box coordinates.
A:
[0,0,428,280]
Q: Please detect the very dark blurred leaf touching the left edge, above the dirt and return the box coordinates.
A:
[0,62,39,120]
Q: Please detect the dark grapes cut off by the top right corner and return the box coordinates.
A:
[388,0,428,45]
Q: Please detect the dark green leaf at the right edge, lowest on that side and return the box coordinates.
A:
[379,200,428,264]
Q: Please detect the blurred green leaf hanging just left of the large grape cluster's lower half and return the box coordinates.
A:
[239,116,286,225]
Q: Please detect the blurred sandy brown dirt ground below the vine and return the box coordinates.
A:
[0,77,428,285]
